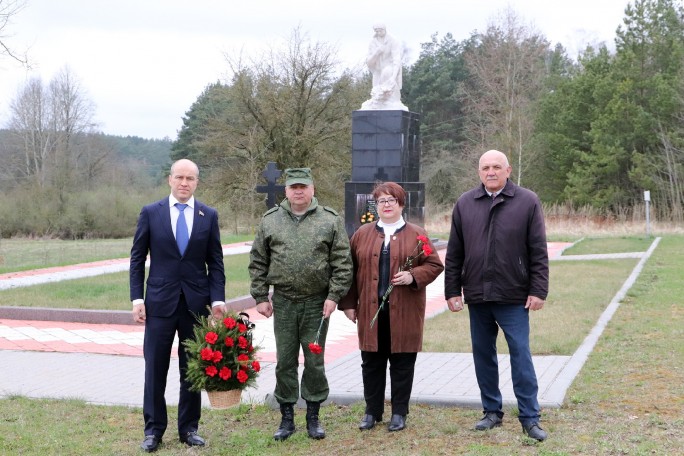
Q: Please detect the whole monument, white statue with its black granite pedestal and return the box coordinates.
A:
[344,24,425,236]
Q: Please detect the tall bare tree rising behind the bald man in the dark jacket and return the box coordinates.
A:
[461,8,551,184]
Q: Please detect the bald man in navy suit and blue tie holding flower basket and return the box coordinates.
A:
[130,159,226,453]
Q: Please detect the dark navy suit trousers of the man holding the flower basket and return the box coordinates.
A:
[143,297,202,437]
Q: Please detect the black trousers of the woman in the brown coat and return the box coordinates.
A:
[361,310,418,417]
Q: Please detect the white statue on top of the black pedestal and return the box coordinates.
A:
[361,24,408,111]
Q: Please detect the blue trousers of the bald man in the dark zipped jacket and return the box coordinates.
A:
[468,302,540,425]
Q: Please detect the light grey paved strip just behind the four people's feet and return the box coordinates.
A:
[0,350,570,408]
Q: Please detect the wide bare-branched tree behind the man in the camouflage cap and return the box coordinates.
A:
[174,29,367,214]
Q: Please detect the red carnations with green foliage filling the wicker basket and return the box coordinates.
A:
[183,311,261,392]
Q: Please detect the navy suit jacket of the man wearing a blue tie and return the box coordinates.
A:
[130,197,226,317]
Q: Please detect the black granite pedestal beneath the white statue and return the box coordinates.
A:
[344,110,425,236]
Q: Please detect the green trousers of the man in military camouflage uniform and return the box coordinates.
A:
[273,293,330,404]
